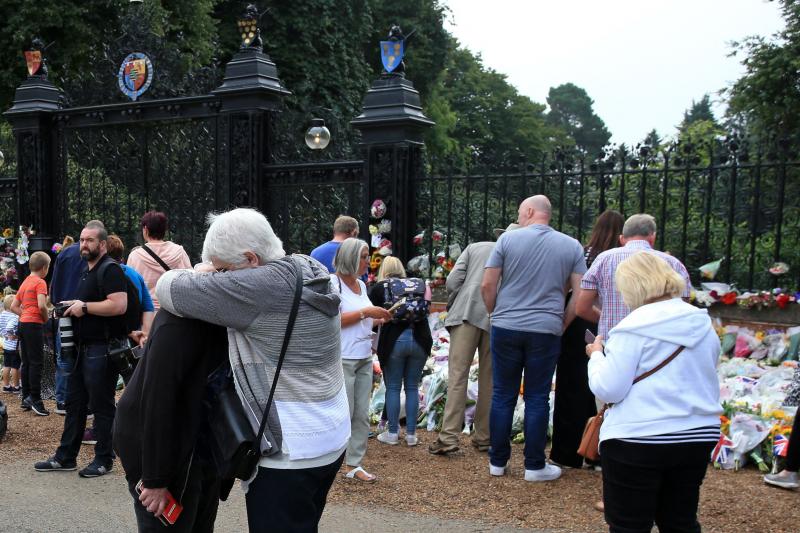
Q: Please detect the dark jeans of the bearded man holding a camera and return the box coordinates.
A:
[55,344,119,468]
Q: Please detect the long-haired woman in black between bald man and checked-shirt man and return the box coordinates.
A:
[550,210,625,468]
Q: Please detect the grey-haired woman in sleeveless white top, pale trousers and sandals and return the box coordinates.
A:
[333,237,392,483]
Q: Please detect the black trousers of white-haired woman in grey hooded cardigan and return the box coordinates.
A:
[247,454,344,533]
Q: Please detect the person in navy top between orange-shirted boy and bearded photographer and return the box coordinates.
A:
[50,238,86,415]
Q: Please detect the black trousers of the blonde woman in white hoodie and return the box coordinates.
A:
[600,440,714,533]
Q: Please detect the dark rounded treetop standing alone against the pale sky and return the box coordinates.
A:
[547,83,611,156]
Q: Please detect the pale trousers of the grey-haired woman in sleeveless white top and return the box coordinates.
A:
[342,357,372,466]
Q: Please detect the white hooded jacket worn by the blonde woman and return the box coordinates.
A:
[588,298,722,442]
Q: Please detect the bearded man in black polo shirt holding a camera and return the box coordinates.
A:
[34,220,128,478]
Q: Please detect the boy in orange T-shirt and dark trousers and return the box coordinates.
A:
[11,252,50,416]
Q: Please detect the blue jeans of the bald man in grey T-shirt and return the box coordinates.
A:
[489,326,561,470]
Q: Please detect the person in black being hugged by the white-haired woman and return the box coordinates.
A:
[114,309,228,532]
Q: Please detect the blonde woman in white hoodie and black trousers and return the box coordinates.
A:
[586,252,722,532]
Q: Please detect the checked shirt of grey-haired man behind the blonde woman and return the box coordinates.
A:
[581,240,692,340]
